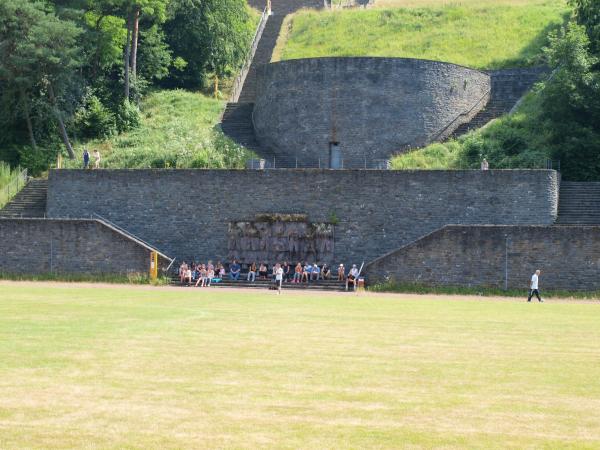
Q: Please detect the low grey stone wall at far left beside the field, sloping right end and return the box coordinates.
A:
[0,219,169,274]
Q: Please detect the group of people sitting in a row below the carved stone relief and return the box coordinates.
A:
[179,260,359,290]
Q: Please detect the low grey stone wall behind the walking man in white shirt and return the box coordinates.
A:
[366,226,600,291]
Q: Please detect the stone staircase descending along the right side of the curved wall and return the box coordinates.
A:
[450,67,548,138]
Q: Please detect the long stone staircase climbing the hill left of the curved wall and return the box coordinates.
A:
[221,0,323,160]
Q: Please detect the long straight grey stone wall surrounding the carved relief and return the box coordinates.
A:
[47,169,558,264]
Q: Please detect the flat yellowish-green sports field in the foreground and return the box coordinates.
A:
[0,282,600,449]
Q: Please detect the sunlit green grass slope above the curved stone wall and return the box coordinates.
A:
[277,0,568,69]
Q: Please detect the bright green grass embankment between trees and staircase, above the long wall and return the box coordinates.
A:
[66,90,255,168]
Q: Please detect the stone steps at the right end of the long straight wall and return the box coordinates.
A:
[556,181,600,225]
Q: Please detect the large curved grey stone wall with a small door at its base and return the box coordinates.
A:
[253,58,491,168]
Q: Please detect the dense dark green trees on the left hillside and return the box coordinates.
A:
[0,0,254,171]
